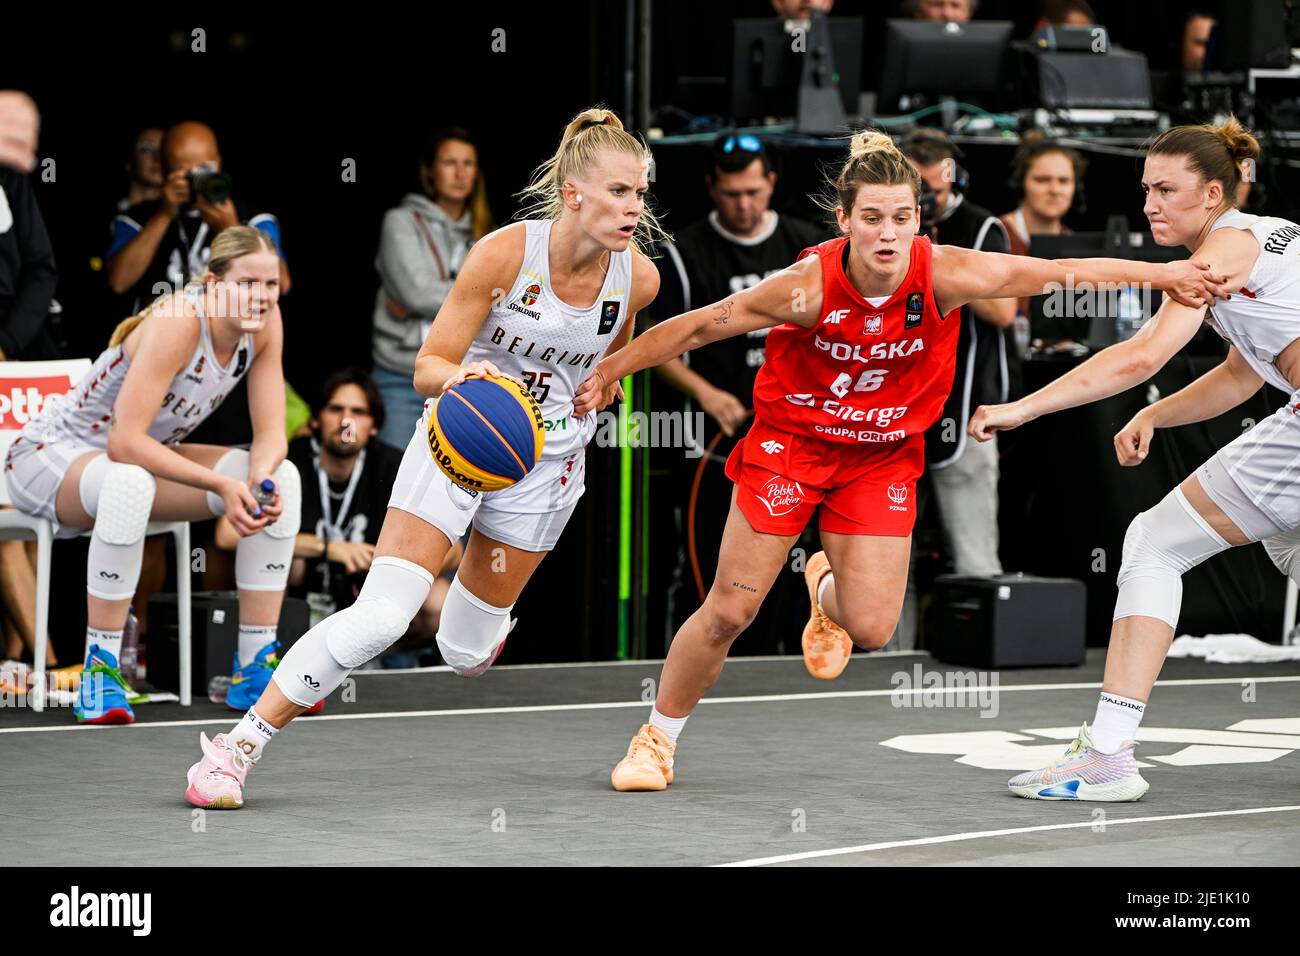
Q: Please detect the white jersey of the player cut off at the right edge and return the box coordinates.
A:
[1205,209,1300,394]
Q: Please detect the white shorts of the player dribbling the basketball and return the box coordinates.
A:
[389,410,586,551]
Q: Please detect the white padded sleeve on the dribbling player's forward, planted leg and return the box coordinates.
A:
[272,555,433,708]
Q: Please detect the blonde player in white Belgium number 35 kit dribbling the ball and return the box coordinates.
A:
[186,109,659,809]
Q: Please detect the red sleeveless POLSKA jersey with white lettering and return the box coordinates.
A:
[754,237,965,444]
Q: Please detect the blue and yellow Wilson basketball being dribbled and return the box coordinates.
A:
[429,376,546,492]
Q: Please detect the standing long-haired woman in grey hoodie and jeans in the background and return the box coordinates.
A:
[377,127,495,447]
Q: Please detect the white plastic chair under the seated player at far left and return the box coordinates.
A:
[0,359,192,713]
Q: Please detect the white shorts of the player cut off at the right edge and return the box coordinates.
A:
[1196,392,1300,540]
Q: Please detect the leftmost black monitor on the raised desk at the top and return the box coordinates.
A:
[731,17,862,125]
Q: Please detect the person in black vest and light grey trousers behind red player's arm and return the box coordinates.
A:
[900,129,1017,575]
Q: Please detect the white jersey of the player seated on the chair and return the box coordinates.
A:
[22,289,254,449]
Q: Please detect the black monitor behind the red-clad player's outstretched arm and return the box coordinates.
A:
[1030,231,1187,351]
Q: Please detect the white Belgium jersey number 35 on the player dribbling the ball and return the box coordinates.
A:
[464,219,633,459]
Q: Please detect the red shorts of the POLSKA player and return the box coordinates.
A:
[727,421,926,537]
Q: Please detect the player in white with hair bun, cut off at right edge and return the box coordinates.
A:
[970,118,1300,801]
